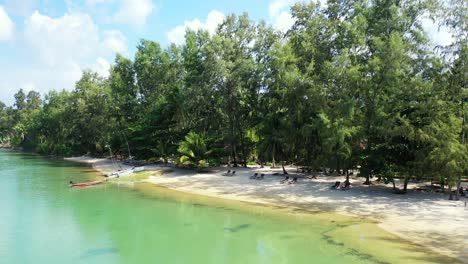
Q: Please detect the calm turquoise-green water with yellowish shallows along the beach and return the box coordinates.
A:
[0,150,453,264]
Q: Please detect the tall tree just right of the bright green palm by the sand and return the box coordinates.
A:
[212,13,259,166]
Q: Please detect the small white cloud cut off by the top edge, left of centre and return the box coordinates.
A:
[113,0,156,26]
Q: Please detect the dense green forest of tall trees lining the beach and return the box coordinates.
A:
[0,0,468,195]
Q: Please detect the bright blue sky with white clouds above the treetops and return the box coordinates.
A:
[0,0,452,105]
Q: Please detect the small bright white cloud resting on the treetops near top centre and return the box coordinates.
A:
[166,10,225,45]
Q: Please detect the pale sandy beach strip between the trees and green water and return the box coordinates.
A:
[66,157,468,263]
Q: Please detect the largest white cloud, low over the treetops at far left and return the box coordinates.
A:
[0,11,128,105]
